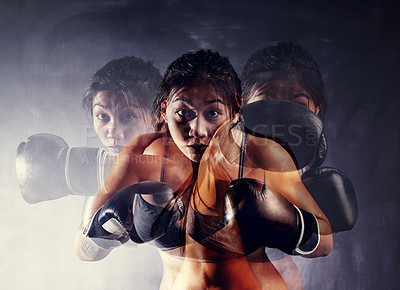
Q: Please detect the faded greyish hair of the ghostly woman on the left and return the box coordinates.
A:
[82,56,161,113]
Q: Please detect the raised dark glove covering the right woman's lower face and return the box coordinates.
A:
[242,100,326,169]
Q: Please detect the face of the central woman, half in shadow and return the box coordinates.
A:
[163,81,231,162]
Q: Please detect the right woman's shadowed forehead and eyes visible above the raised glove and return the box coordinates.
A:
[248,74,319,114]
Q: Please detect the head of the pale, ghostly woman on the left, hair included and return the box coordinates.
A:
[82,56,161,155]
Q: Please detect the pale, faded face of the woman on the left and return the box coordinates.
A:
[92,91,149,155]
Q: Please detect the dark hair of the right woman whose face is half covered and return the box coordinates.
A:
[242,42,326,115]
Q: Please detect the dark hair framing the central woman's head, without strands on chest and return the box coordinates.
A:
[153,50,242,131]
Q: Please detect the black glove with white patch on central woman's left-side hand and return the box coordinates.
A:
[84,181,184,249]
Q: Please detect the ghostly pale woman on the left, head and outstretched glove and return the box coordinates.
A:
[16,57,161,203]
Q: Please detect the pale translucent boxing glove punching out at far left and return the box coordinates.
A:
[16,133,109,203]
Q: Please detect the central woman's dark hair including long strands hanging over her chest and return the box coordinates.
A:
[152,50,242,251]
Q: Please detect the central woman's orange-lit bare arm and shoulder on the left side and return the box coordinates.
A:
[75,135,192,261]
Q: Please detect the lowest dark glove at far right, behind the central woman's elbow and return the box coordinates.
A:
[301,167,358,233]
